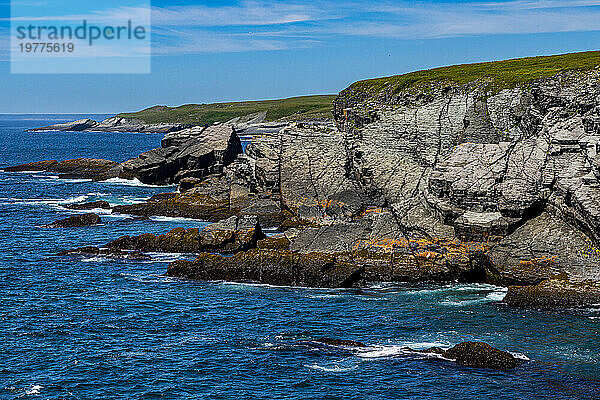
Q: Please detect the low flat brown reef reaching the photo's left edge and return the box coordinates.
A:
[4,158,118,180]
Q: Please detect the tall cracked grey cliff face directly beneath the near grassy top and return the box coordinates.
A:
[334,69,600,279]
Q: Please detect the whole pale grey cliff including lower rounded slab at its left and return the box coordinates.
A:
[239,65,600,283]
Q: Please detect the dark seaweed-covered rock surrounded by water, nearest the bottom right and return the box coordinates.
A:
[409,342,523,370]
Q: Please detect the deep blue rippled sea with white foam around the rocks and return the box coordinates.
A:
[0,115,600,400]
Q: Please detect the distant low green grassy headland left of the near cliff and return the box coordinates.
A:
[118,95,335,125]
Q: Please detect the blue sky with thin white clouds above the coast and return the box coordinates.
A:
[0,0,600,113]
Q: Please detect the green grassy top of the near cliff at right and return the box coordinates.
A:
[349,51,600,94]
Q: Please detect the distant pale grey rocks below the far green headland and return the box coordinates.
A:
[30,117,187,133]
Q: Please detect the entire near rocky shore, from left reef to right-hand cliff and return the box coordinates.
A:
[5,58,600,308]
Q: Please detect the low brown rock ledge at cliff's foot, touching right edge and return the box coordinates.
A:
[503,278,600,309]
